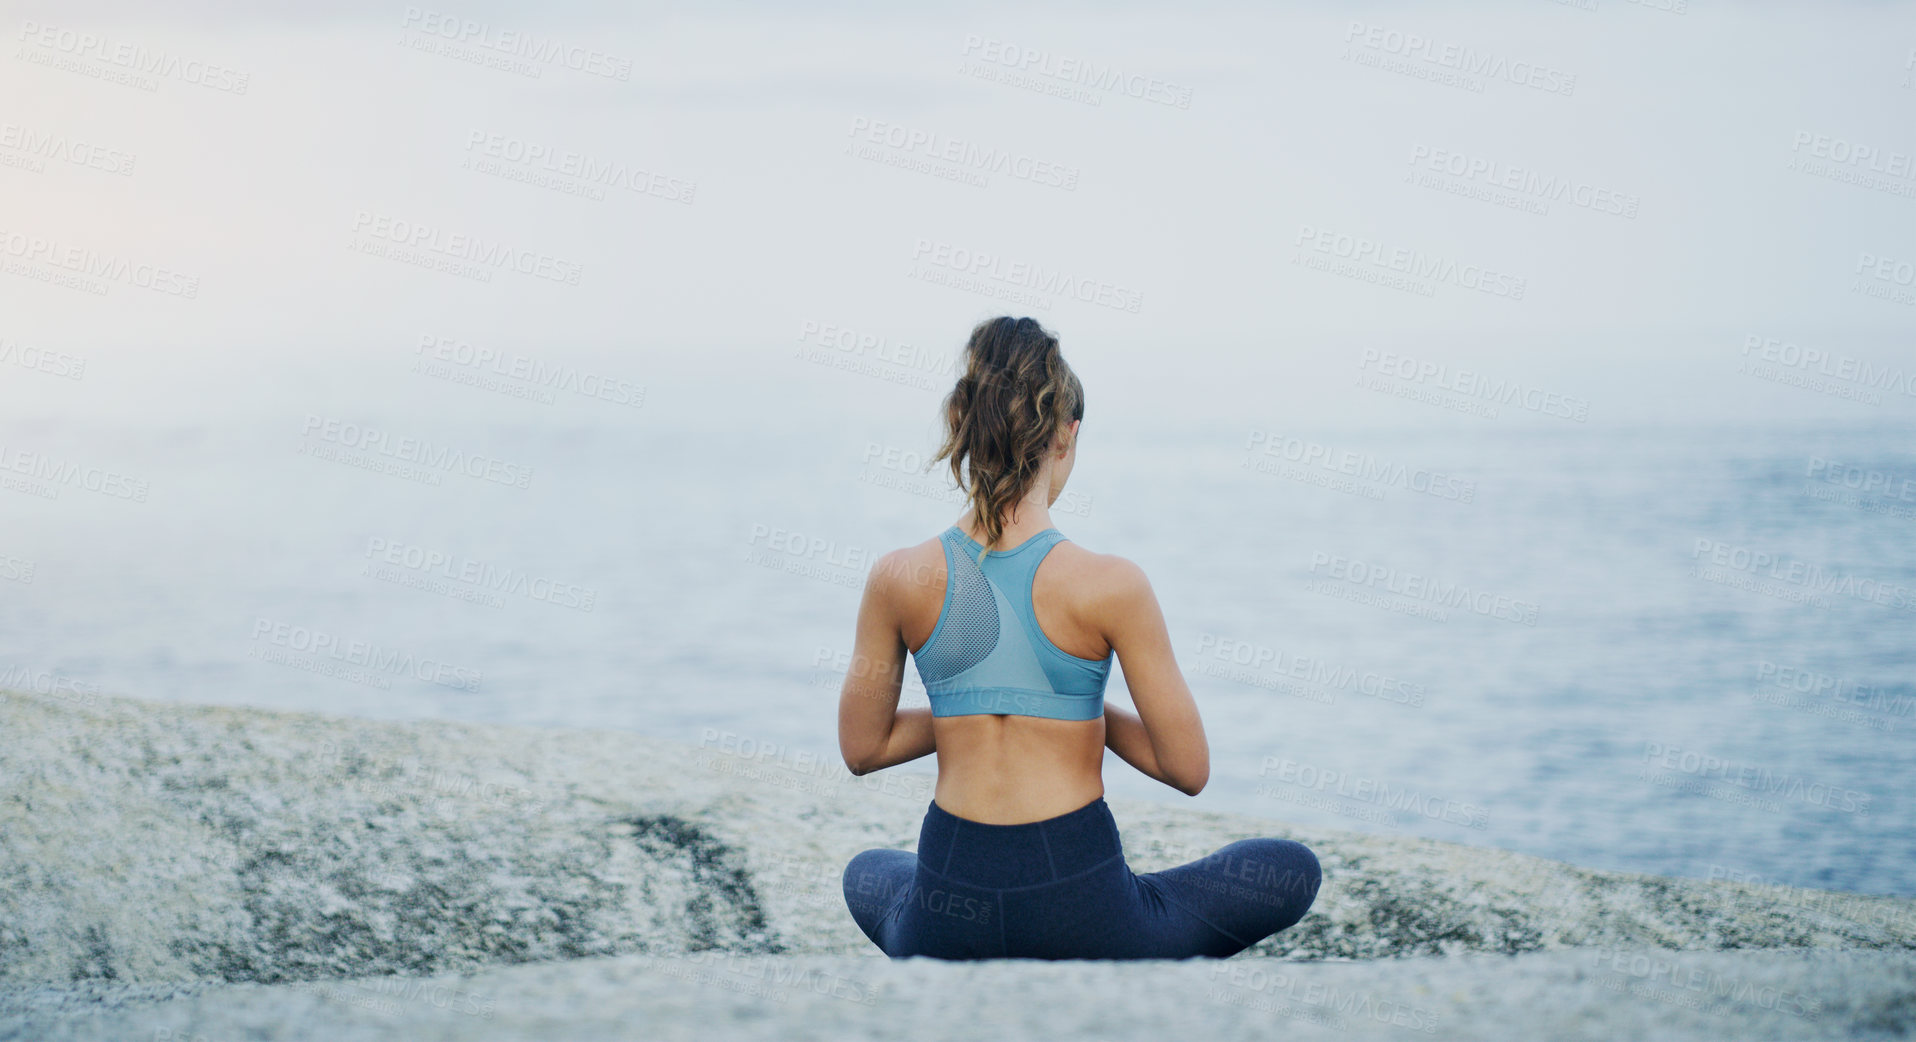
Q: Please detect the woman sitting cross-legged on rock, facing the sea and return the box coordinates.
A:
[839,318,1320,960]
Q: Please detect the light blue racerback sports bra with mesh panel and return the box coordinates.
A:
[912,525,1111,720]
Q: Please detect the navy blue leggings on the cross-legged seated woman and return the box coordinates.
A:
[845,797,1322,960]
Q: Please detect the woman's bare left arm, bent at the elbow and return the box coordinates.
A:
[839,550,937,774]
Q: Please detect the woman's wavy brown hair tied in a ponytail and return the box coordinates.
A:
[931,316,1084,559]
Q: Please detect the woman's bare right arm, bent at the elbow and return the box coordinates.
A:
[1098,557,1211,797]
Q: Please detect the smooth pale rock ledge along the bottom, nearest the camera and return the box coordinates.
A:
[11,950,1916,1042]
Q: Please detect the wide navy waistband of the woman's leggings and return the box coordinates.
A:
[918,797,1125,887]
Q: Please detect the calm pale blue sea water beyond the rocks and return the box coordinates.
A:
[0,358,1916,895]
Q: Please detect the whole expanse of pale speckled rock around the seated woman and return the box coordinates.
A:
[0,681,1916,1040]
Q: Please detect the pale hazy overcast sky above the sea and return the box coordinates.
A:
[0,0,1916,421]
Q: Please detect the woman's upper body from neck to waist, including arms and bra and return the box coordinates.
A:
[854,505,1211,824]
